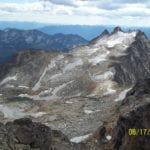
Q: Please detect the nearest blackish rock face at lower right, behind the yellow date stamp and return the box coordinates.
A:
[113,103,150,150]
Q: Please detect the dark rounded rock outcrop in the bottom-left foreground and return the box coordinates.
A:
[0,118,72,150]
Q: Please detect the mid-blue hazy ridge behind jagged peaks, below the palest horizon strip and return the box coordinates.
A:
[39,25,150,40]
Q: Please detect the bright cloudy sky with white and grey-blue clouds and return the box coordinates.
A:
[0,0,150,26]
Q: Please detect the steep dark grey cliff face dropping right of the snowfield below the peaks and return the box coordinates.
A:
[113,31,150,85]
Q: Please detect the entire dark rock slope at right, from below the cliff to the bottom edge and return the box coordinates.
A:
[110,79,150,150]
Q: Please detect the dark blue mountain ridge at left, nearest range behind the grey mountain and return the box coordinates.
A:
[0,29,88,62]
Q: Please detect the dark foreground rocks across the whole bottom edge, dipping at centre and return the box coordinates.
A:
[0,103,150,150]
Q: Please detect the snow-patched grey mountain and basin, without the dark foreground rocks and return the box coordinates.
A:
[0,27,150,148]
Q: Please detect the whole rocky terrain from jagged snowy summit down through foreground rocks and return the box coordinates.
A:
[0,27,150,150]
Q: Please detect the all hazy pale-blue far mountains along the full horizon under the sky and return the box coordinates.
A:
[0,21,150,40]
